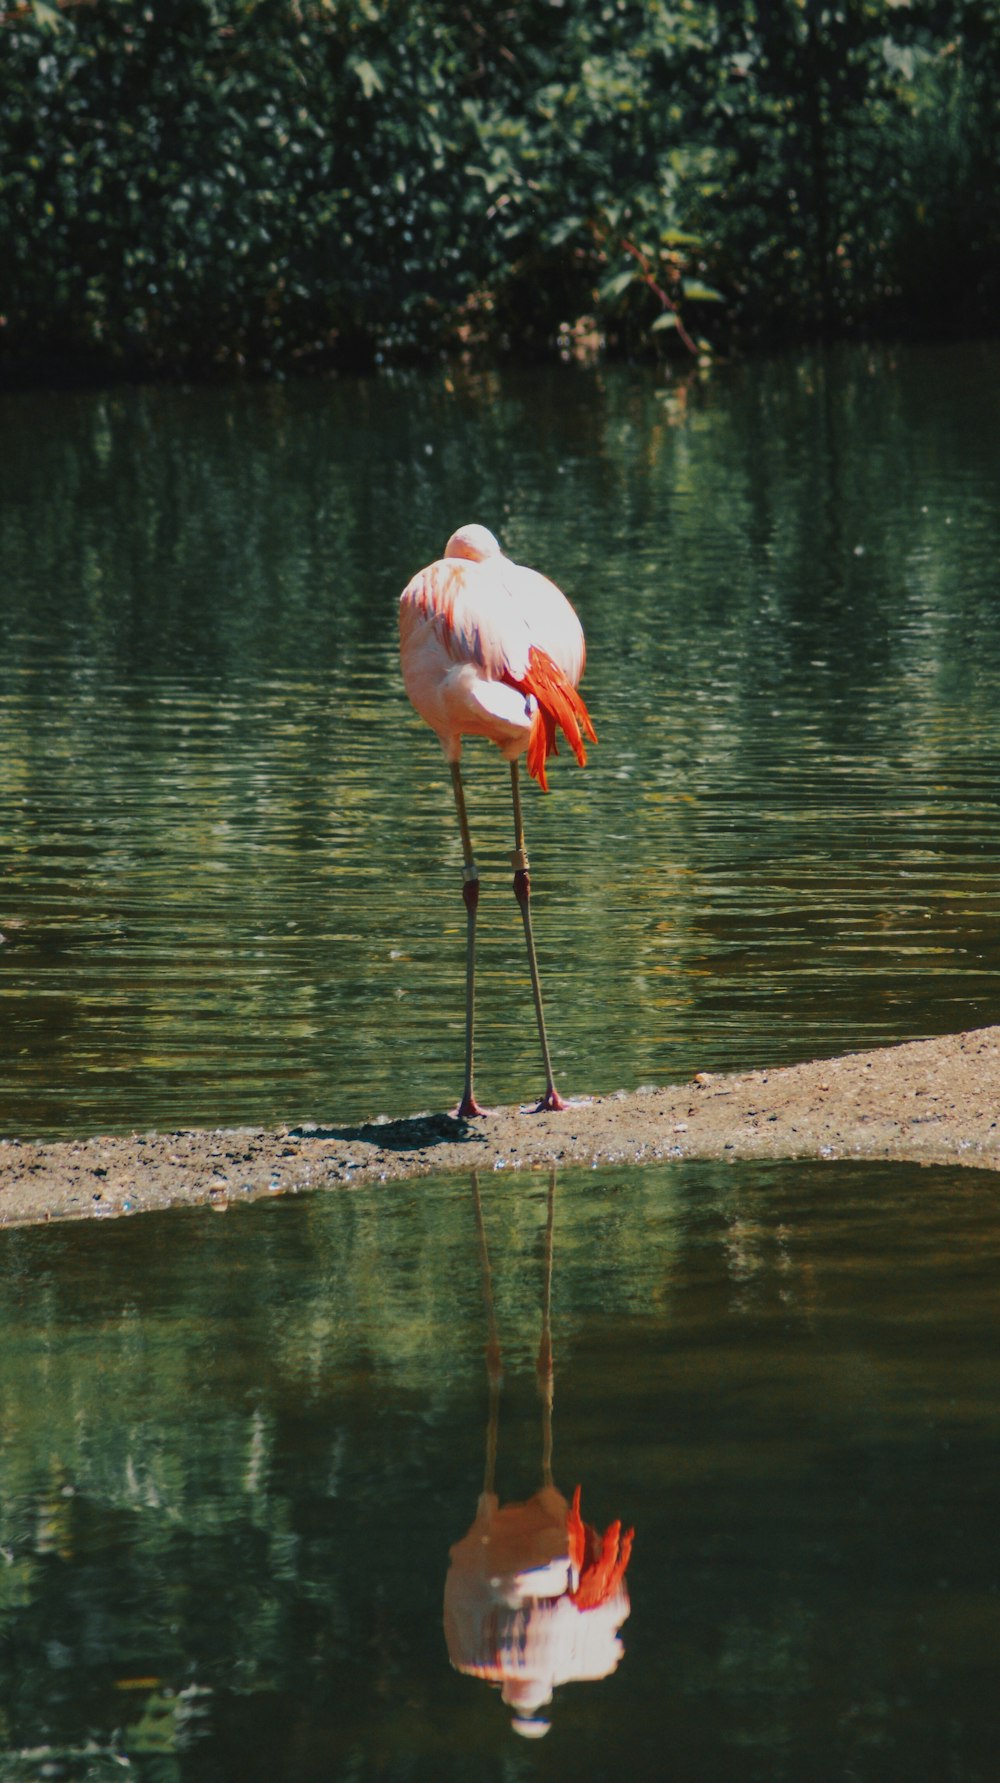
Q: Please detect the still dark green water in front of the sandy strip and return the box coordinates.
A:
[0,1163,1000,1783]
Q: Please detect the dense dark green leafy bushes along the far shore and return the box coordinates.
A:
[0,0,1000,373]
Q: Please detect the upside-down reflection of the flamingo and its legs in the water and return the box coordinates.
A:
[444,1171,633,1738]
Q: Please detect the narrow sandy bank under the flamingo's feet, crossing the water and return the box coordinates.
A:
[0,1027,1000,1225]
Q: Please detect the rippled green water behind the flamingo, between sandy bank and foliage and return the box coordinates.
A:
[0,346,1000,1136]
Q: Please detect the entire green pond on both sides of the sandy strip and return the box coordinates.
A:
[0,344,1000,1783]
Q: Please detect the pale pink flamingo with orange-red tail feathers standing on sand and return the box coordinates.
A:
[399,526,597,1118]
